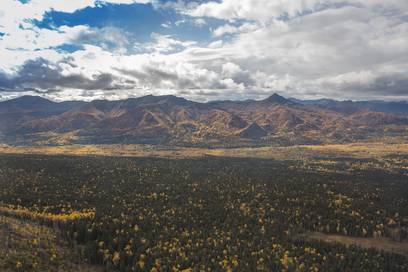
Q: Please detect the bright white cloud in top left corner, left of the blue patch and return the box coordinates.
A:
[0,0,142,73]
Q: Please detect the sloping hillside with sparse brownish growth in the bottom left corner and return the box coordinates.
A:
[0,214,103,272]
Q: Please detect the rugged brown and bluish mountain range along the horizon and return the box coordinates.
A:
[0,94,408,147]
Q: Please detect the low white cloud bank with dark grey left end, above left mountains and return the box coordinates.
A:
[0,45,250,100]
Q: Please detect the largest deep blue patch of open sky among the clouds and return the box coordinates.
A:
[34,1,225,48]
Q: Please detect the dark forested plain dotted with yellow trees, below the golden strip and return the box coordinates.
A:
[0,154,408,272]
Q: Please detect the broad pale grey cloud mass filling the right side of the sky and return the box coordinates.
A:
[196,5,408,99]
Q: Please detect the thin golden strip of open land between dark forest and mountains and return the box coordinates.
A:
[0,142,408,160]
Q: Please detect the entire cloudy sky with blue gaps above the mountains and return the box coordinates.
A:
[0,0,408,102]
